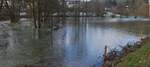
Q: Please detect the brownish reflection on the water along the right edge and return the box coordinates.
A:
[113,22,150,36]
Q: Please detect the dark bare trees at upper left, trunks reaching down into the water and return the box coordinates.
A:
[0,0,64,28]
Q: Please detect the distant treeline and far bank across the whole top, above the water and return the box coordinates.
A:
[0,0,149,27]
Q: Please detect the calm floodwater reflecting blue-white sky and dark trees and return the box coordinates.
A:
[0,19,150,67]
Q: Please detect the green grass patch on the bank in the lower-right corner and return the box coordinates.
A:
[116,41,150,67]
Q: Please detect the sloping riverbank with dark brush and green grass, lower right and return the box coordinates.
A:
[103,37,150,67]
